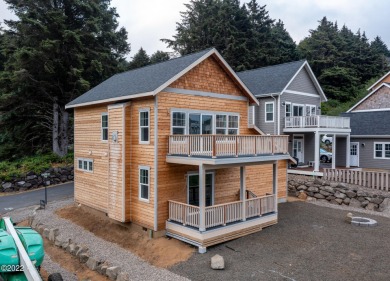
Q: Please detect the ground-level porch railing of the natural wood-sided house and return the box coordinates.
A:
[169,195,275,229]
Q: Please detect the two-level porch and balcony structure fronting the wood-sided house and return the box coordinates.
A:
[166,133,290,253]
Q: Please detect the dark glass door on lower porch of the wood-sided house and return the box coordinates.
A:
[187,173,214,206]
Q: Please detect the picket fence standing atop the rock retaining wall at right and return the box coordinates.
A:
[323,168,390,191]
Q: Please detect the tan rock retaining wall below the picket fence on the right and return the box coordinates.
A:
[288,175,390,212]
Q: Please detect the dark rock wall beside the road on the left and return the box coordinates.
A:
[0,166,74,192]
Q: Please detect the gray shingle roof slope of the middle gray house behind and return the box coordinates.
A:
[237,60,306,97]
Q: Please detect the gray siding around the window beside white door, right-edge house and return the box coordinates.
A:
[351,138,390,170]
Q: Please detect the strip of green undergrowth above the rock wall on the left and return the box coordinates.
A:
[0,152,73,181]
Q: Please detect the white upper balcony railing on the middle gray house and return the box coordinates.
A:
[284,115,350,129]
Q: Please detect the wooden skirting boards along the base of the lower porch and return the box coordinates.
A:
[166,219,278,247]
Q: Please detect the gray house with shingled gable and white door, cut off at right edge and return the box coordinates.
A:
[342,72,390,170]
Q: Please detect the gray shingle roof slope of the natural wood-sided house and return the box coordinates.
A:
[67,48,211,106]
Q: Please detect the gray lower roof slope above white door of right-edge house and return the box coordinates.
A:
[341,111,390,135]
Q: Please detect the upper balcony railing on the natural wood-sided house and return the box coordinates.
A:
[168,135,288,158]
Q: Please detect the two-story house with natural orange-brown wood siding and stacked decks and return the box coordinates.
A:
[66,49,291,252]
